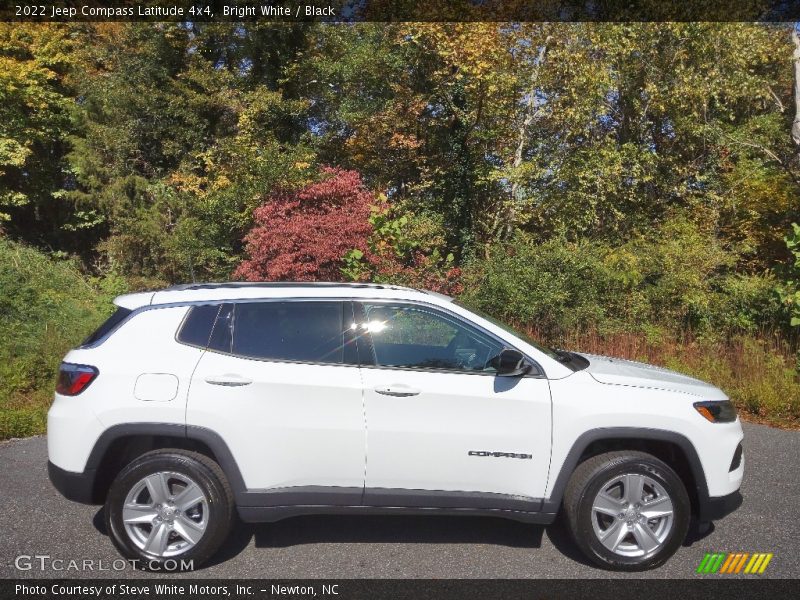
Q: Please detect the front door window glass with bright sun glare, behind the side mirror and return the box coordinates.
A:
[361,304,503,372]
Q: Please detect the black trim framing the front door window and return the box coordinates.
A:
[353,298,547,379]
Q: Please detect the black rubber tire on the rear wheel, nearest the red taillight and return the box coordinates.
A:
[105,449,234,571]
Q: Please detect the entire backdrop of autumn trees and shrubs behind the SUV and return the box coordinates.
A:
[0,22,800,435]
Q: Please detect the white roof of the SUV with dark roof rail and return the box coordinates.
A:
[114,281,453,310]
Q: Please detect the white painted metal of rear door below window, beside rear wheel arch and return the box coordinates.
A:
[186,352,366,490]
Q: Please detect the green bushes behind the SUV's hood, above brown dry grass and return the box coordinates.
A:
[464,217,784,340]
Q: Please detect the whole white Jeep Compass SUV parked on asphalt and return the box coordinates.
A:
[47,283,744,570]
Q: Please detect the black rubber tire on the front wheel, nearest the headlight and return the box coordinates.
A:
[564,450,691,571]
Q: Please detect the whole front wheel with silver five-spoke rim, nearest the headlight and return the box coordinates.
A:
[564,451,691,571]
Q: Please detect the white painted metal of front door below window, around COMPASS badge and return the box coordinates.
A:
[362,368,551,498]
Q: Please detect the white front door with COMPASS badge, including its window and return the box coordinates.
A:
[356,302,551,510]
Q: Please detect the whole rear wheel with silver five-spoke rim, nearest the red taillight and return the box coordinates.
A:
[105,450,233,570]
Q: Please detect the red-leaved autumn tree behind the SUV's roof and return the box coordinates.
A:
[234,167,375,281]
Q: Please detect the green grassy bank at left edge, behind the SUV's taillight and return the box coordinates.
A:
[0,237,112,439]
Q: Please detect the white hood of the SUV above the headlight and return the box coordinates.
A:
[582,354,728,400]
